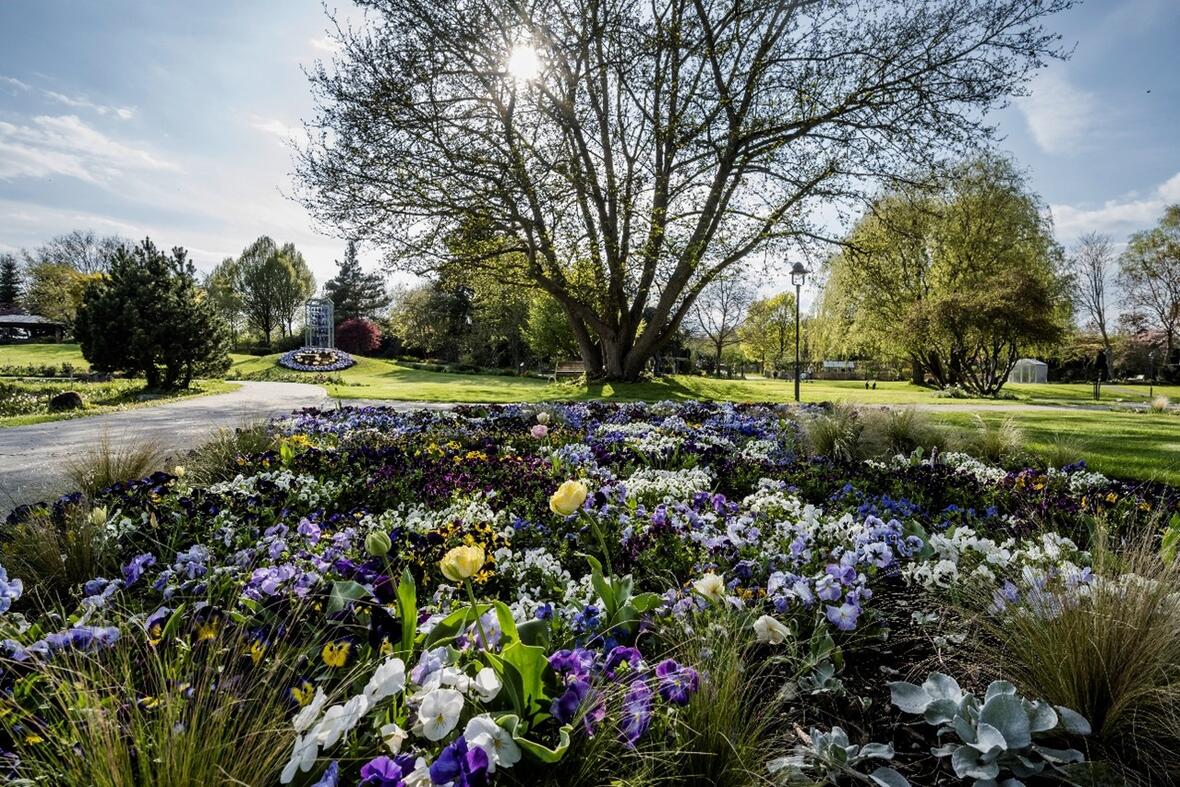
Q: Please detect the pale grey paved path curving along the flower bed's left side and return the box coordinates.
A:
[0,382,333,513]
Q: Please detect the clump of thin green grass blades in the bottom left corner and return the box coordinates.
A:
[7,616,297,787]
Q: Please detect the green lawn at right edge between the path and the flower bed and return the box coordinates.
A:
[935,408,1180,485]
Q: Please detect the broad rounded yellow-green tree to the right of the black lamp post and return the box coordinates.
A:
[824,156,1070,396]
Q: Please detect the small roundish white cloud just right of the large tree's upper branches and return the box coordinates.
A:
[1016,70,1100,155]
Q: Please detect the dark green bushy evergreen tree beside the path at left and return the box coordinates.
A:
[77,240,230,391]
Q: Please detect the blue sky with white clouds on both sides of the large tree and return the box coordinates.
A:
[0,0,1180,294]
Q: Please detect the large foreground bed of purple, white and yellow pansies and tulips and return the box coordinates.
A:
[0,402,1175,787]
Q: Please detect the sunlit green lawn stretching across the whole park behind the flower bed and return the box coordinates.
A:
[0,345,1180,484]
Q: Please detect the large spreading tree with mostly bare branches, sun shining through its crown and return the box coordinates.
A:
[296,0,1074,379]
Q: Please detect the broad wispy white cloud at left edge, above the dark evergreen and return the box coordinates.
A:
[0,114,179,184]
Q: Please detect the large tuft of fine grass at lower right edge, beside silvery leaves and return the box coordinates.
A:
[981,531,1180,785]
